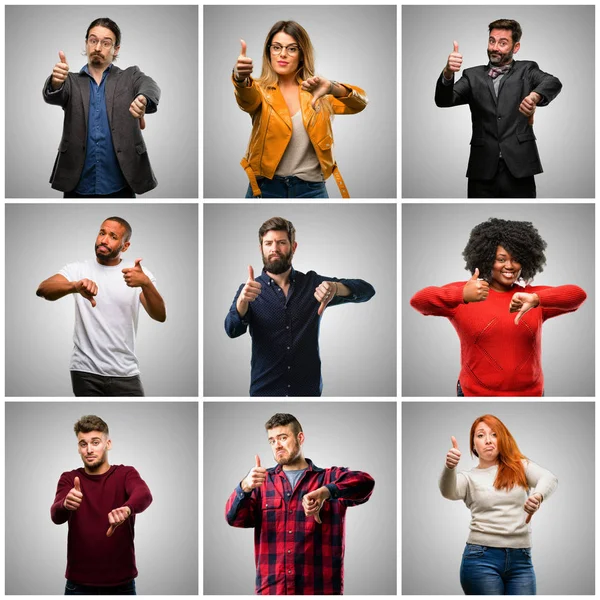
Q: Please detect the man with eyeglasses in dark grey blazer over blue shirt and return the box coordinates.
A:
[43,18,160,198]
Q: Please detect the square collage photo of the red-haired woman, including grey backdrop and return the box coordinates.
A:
[402,401,596,596]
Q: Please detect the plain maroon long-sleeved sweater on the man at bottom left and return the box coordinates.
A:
[50,465,152,586]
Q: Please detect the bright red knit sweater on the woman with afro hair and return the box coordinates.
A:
[410,281,586,396]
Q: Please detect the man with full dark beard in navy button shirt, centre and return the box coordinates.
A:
[225,217,375,396]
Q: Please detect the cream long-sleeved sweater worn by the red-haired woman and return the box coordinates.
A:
[439,460,558,548]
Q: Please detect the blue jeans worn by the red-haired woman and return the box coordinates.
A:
[460,544,535,596]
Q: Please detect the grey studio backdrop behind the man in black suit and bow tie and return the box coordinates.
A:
[402,5,595,198]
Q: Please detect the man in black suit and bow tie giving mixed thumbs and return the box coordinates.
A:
[435,19,562,198]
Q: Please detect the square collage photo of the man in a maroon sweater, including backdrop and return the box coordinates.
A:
[5,401,199,596]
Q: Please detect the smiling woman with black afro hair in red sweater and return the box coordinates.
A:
[410,218,586,396]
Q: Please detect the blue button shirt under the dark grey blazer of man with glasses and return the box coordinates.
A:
[75,65,127,196]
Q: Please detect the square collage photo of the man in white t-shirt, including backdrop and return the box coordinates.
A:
[5,204,198,397]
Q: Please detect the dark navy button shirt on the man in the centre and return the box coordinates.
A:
[225,269,375,396]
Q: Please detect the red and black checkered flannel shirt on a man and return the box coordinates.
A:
[225,459,375,595]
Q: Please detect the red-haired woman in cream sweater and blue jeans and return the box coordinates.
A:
[439,415,558,595]
